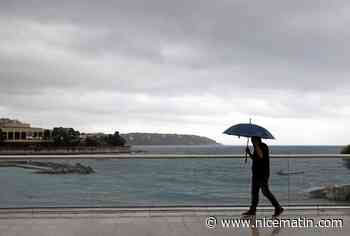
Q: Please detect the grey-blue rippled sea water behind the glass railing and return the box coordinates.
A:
[0,146,350,208]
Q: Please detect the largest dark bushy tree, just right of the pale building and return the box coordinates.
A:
[52,127,80,146]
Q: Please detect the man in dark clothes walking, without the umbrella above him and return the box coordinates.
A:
[242,137,283,217]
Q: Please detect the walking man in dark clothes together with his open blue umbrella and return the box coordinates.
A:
[224,120,283,217]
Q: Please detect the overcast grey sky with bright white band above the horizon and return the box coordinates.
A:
[0,0,350,145]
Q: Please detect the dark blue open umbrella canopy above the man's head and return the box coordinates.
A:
[224,123,275,139]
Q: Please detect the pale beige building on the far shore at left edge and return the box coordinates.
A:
[0,118,47,143]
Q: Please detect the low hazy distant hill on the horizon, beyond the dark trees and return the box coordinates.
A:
[121,133,218,145]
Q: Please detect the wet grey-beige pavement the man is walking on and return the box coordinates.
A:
[0,207,350,236]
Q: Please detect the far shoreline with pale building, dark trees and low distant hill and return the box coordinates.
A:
[0,118,218,147]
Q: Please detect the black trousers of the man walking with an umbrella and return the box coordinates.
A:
[250,175,281,210]
